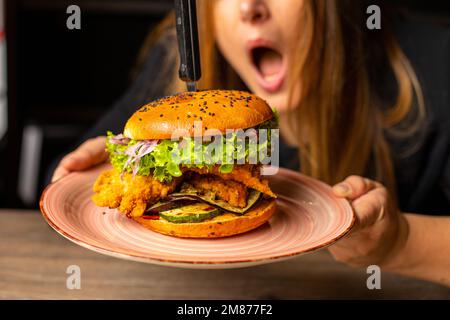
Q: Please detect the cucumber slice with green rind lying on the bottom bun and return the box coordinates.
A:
[159,202,221,223]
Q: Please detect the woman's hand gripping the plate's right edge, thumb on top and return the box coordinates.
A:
[329,176,409,268]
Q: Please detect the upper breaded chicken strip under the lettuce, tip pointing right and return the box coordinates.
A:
[183,164,277,198]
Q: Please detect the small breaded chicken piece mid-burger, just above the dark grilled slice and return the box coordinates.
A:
[188,173,248,208]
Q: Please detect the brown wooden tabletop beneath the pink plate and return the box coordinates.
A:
[0,210,450,299]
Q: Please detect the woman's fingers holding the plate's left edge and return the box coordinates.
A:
[52,136,108,182]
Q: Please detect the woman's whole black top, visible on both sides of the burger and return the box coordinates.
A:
[79,14,450,215]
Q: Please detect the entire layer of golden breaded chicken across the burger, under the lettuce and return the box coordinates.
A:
[92,164,276,217]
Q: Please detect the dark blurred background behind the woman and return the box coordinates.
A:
[0,0,449,208]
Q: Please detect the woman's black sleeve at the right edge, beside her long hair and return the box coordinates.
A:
[391,15,450,215]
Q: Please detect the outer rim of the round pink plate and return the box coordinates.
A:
[39,163,356,269]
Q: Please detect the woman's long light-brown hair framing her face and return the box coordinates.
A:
[135,0,424,194]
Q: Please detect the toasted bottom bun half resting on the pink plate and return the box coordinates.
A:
[132,199,276,238]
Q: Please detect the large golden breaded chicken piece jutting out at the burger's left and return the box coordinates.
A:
[92,169,180,217]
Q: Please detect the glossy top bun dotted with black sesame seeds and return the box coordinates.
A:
[124,90,274,140]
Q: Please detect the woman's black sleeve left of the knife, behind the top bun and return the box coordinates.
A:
[80,30,176,143]
